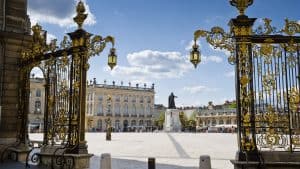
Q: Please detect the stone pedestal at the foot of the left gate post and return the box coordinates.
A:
[38,146,93,169]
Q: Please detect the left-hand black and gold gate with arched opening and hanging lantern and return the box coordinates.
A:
[19,1,117,166]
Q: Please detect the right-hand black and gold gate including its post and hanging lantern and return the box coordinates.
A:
[190,0,300,161]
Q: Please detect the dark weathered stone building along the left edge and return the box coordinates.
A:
[0,0,31,144]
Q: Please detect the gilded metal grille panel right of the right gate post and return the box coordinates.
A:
[252,43,300,151]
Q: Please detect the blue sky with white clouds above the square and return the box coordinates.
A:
[28,0,300,106]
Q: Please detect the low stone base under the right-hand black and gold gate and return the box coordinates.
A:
[230,151,300,169]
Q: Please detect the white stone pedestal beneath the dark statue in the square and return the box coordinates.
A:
[164,109,181,132]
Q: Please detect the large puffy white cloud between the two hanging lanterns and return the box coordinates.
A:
[106,50,193,82]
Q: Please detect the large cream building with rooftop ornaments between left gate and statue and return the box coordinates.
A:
[86,79,155,131]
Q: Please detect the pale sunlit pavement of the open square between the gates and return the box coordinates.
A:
[30,133,237,169]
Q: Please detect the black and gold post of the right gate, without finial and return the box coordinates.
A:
[229,11,258,161]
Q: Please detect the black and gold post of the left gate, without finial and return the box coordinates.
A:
[68,28,91,154]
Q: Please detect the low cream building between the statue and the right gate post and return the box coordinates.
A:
[196,102,237,132]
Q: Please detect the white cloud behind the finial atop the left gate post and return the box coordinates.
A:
[28,0,96,27]
